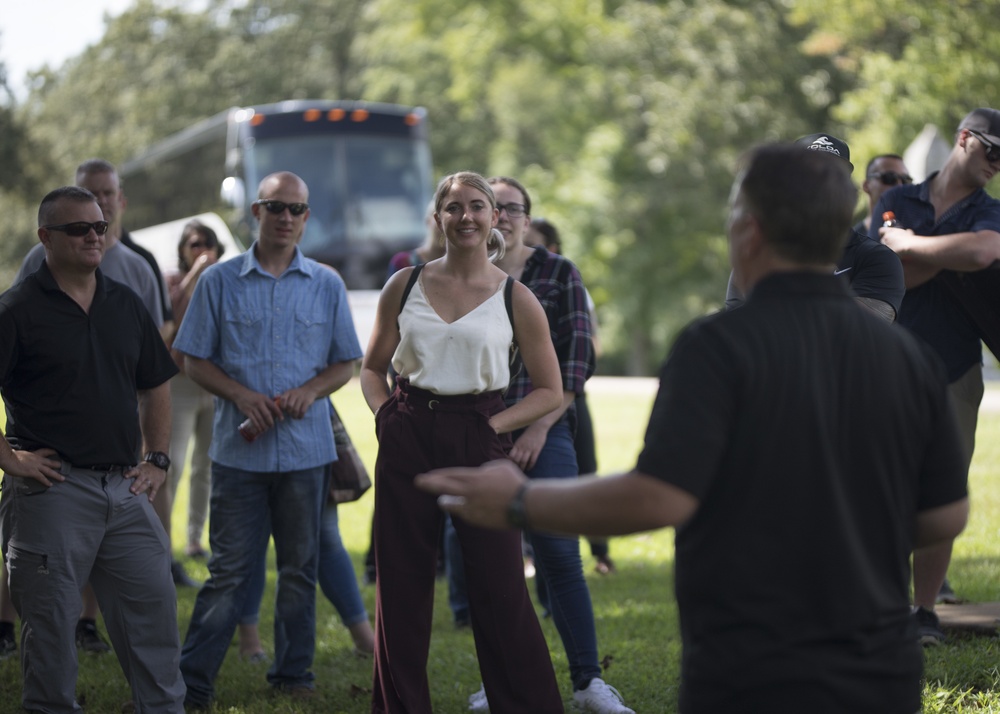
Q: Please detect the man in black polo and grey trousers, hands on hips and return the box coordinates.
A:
[0,186,184,712]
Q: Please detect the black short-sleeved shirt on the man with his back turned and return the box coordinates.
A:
[637,273,966,714]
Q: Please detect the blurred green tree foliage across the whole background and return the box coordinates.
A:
[0,0,1000,372]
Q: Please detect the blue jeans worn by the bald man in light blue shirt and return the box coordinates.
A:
[181,463,327,706]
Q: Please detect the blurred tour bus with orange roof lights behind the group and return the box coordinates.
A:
[119,100,433,290]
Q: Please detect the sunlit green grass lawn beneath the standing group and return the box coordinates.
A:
[0,381,1000,714]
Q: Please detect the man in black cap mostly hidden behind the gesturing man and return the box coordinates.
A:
[726,133,906,322]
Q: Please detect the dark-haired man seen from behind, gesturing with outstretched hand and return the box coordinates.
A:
[418,144,968,714]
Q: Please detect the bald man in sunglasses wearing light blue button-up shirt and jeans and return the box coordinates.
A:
[174,172,361,708]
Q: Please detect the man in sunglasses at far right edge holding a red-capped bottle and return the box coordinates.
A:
[869,107,1000,644]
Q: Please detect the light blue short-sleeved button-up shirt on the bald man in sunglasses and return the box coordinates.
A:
[173,243,361,473]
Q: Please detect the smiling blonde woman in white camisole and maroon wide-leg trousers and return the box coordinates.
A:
[361,172,563,714]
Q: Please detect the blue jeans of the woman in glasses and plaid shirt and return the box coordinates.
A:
[528,418,601,690]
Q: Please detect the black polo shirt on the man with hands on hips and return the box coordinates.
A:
[0,263,177,466]
